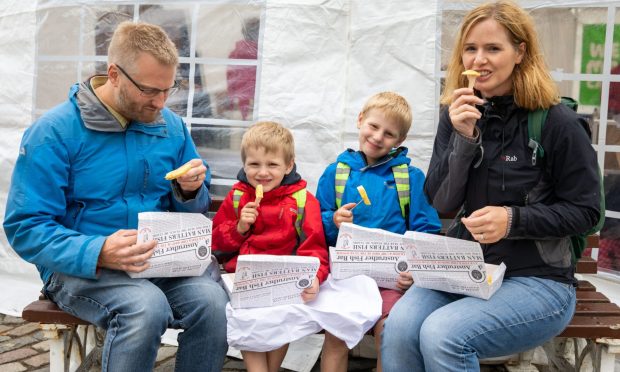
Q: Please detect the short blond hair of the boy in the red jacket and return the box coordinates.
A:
[241,121,295,164]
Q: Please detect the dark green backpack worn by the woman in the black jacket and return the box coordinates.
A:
[527,97,605,263]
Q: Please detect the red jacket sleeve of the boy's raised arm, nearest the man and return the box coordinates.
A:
[211,190,250,252]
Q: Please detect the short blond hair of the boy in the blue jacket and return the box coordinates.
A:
[361,92,412,139]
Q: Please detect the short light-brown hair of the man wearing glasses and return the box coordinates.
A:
[108,21,179,69]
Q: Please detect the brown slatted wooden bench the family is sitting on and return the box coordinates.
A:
[22,206,620,372]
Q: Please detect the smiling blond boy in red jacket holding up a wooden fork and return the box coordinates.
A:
[212,121,329,372]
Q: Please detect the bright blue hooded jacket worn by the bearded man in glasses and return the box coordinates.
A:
[4,83,211,282]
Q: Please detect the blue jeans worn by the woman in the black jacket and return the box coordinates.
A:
[381,277,576,372]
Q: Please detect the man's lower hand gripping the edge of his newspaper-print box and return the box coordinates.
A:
[97,230,157,273]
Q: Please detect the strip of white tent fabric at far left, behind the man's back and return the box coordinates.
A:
[0,0,41,315]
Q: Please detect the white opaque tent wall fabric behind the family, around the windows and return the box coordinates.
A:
[0,0,620,315]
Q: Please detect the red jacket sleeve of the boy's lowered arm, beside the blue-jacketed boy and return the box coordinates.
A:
[297,192,329,283]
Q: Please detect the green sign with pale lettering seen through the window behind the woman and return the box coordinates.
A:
[579,24,620,106]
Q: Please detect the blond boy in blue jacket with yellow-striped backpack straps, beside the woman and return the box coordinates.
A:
[316,92,441,371]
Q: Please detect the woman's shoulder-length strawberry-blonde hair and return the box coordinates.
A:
[441,0,560,110]
